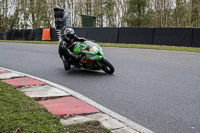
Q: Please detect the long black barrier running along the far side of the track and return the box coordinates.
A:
[1,27,200,47]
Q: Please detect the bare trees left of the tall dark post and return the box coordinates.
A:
[0,0,57,31]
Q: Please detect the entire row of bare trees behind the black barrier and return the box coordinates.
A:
[0,0,200,32]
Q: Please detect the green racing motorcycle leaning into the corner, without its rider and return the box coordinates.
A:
[65,41,115,74]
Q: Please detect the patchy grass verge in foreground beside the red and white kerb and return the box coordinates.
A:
[0,81,110,133]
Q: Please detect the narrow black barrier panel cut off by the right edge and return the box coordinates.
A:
[192,28,200,47]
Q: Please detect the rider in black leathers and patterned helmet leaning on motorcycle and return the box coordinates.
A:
[58,28,86,70]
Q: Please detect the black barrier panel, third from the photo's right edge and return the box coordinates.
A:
[118,27,154,44]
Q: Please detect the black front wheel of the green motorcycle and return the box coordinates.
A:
[101,59,115,74]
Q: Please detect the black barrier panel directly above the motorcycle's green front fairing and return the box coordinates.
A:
[87,28,119,43]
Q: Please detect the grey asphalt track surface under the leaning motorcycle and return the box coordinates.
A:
[0,43,200,133]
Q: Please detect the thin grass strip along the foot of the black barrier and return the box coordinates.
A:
[0,40,200,53]
